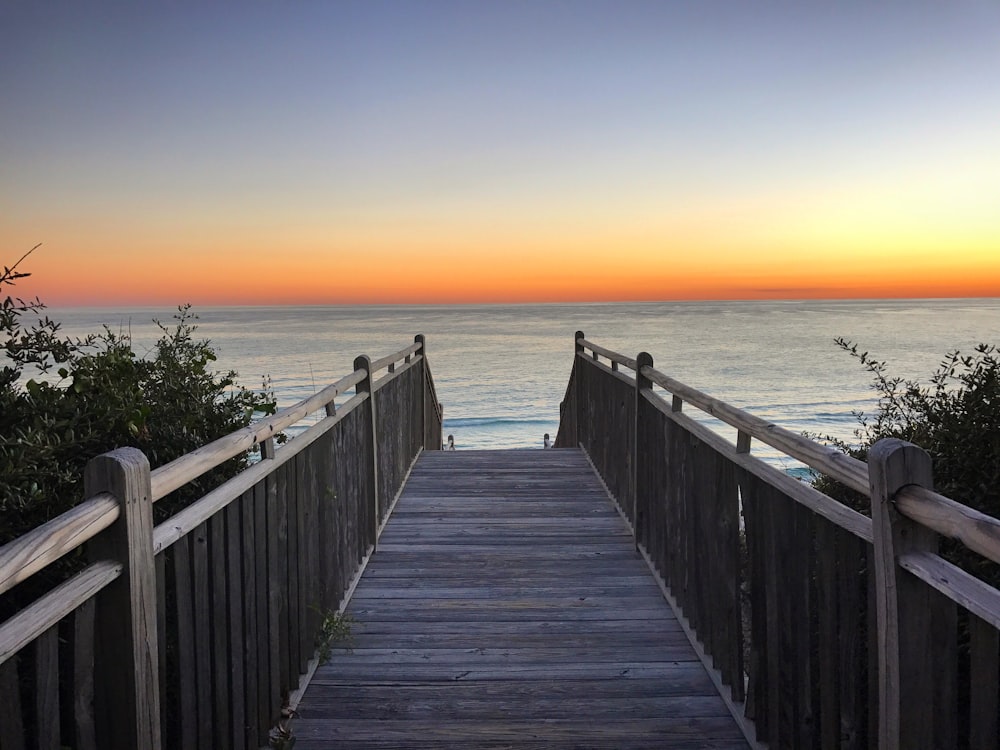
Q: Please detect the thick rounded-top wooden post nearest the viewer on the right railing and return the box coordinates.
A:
[868,438,938,750]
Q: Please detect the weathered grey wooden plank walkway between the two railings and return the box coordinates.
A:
[293,449,747,750]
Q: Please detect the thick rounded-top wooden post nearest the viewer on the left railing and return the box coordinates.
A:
[85,448,160,750]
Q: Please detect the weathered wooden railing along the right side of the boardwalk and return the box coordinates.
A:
[556,332,1000,749]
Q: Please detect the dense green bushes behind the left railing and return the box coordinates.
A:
[0,248,275,543]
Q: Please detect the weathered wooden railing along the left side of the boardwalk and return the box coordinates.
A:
[0,336,441,750]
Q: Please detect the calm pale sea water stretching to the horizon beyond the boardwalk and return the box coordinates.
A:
[50,299,1000,472]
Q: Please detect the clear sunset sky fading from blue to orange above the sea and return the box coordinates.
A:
[0,0,1000,306]
